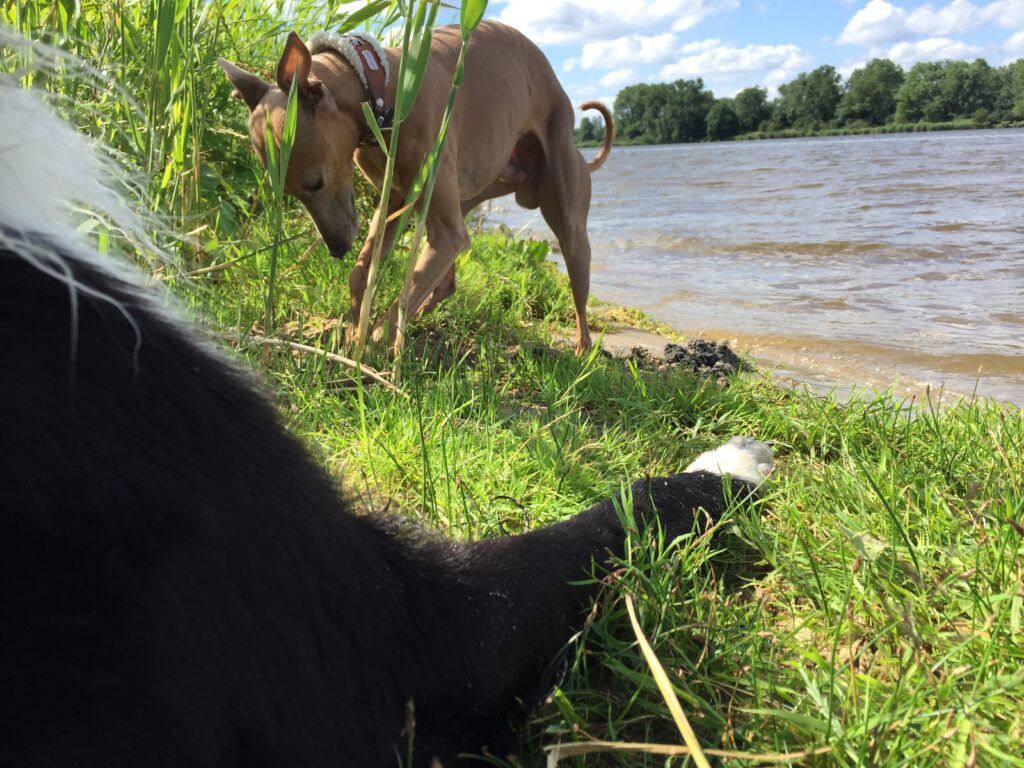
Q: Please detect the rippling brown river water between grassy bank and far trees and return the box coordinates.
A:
[487,130,1024,406]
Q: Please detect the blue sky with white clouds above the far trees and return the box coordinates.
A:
[477,0,1024,112]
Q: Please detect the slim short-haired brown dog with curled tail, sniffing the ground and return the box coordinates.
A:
[220,20,614,352]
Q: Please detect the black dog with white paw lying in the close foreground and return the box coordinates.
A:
[0,75,770,768]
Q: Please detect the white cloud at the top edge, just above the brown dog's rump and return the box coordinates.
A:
[498,0,739,45]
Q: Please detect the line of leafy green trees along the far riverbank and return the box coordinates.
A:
[577,58,1024,144]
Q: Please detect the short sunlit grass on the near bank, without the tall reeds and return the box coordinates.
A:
[194,225,1024,766]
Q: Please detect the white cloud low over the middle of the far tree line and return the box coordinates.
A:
[660,44,811,85]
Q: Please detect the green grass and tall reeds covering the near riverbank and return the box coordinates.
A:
[8,0,1024,766]
